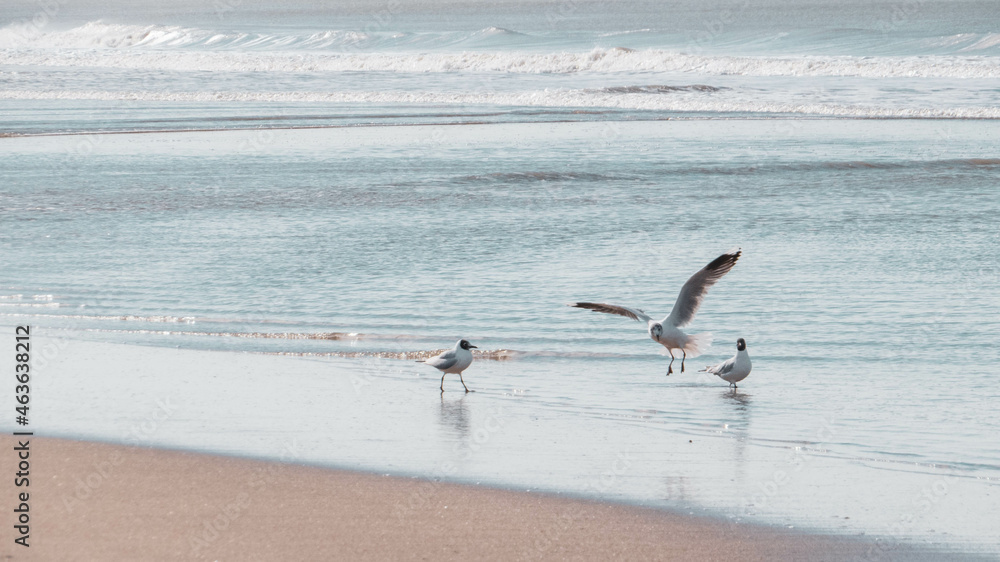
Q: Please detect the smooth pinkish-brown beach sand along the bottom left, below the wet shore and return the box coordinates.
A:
[0,436,939,560]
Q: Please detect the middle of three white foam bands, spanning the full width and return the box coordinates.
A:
[0,46,1000,78]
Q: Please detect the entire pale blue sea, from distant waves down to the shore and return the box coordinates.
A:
[0,0,1000,553]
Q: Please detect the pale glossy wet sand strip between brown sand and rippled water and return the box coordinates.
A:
[0,329,996,559]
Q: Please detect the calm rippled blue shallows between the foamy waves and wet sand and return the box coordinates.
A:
[0,121,1000,543]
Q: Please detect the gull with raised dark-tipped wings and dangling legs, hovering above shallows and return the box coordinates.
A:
[569,249,743,375]
